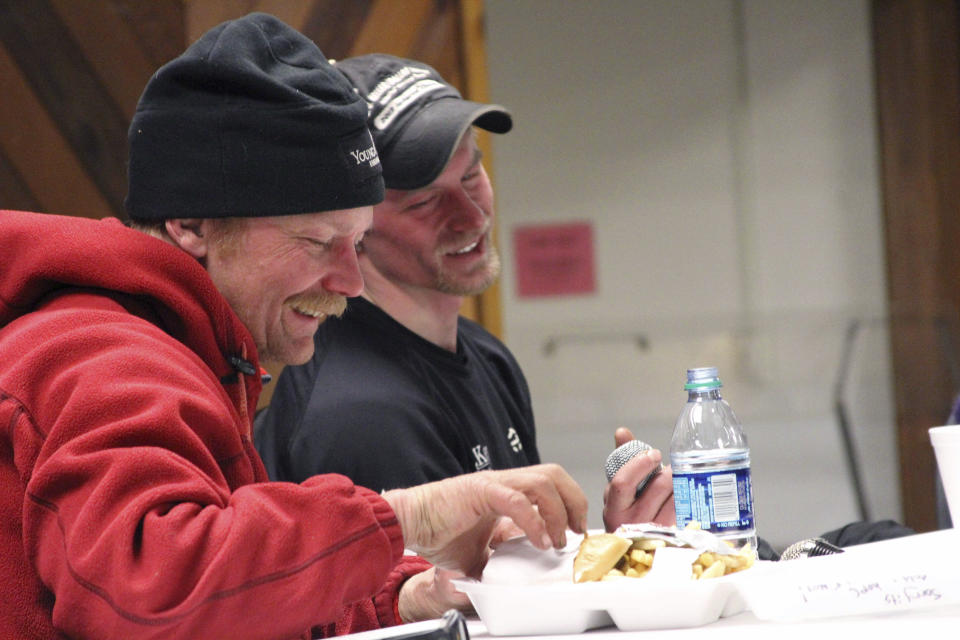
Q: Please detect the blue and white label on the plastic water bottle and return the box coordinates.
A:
[673,467,753,534]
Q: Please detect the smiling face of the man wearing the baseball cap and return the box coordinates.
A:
[361,133,500,296]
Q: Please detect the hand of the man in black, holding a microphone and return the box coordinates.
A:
[603,427,677,531]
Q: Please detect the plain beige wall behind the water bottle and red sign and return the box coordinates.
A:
[486,0,900,544]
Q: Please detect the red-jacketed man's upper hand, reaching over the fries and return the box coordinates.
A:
[383,464,587,578]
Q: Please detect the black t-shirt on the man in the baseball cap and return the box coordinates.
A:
[255,298,540,491]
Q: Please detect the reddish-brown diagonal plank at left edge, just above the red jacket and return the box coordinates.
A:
[0,46,113,218]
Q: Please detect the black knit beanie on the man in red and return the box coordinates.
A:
[125,13,383,221]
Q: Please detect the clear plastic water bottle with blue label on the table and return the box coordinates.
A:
[670,367,757,553]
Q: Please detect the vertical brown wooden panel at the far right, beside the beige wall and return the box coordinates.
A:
[873,0,960,531]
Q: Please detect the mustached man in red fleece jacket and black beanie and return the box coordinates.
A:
[0,14,586,639]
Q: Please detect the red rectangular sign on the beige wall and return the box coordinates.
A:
[513,222,596,298]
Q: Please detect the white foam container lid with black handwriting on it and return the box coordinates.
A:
[740,529,960,620]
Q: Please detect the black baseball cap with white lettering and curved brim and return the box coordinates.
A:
[335,53,513,190]
